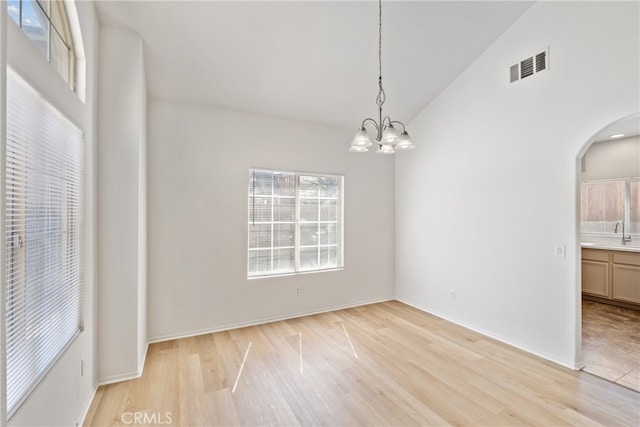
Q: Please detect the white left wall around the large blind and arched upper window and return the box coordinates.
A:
[0,2,98,426]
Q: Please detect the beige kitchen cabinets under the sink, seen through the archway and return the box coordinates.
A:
[582,249,640,306]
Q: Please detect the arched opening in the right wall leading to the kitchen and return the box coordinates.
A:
[577,113,640,391]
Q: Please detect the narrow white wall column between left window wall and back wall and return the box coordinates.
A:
[98,26,147,383]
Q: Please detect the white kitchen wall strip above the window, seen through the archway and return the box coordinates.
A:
[581,136,640,181]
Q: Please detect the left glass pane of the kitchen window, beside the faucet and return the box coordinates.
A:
[581,181,624,233]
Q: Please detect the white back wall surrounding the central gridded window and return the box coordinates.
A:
[147,100,394,340]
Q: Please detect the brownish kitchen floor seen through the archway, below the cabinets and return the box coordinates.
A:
[582,300,640,392]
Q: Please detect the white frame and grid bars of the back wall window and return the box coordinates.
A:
[246,168,344,280]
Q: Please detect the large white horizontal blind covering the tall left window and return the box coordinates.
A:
[4,72,84,413]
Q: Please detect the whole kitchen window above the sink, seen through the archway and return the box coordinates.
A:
[581,179,640,234]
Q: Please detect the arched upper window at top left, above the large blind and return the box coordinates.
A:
[7,0,75,89]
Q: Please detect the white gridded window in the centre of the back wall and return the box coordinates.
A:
[247,170,343,277]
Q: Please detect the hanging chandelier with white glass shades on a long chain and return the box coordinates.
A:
[349,0,415,154]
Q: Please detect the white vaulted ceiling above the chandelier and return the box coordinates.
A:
[96,1,532,129]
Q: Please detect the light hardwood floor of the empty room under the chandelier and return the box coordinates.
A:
[85,301,640,426]
